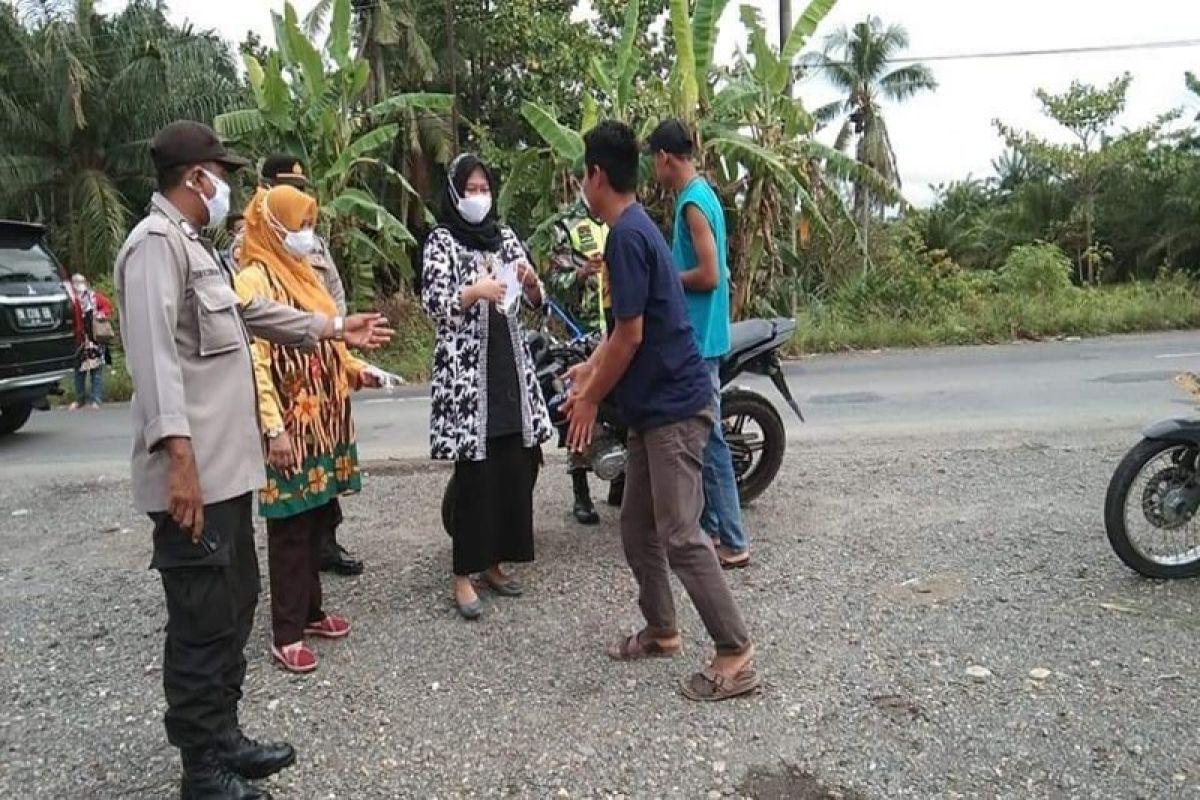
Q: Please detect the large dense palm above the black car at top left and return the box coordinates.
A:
[0,0,241,276]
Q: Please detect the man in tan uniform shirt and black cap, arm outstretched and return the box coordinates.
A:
[114,121,391,800]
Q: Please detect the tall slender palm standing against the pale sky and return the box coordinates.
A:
[808,17,937,231]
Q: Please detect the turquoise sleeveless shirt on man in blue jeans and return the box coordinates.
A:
[672,175,730,359]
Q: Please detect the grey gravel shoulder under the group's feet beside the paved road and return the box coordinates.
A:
[0,431,1200,800]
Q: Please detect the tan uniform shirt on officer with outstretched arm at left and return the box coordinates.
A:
[114,194,329,512]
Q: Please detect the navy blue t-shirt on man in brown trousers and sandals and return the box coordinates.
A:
[605,203,713,431]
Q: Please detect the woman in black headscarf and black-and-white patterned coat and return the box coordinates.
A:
[421,154,553,619]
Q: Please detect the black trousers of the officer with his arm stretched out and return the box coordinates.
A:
[150,494,260,748]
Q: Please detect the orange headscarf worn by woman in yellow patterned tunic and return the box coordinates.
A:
[240,186,337,317]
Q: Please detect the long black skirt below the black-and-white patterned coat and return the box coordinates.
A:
[454,433,541,576]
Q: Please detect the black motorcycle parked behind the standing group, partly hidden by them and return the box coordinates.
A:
[442,300,804,536]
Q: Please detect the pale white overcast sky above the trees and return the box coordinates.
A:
[98,0,1200,205]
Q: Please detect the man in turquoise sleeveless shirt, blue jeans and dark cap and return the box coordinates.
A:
[646,120,750,570]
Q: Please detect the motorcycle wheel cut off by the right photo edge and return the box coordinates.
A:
[1104,439,1200,578]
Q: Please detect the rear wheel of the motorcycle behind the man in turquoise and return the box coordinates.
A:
[721,389,787,505]
